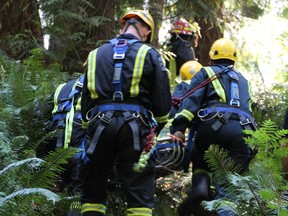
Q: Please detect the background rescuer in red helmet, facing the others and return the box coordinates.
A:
[168,18,197,84]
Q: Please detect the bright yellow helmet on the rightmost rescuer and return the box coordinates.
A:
[209,38,237,62]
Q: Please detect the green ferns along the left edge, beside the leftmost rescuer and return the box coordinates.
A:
[0,46,76,216]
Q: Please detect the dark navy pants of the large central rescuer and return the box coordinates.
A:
[81,111,154,208]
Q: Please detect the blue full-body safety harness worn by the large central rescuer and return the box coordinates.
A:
[86,38,157,155]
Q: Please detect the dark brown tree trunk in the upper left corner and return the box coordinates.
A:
[0,0,43,60]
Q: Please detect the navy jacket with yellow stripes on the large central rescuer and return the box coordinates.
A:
[81,34,171,123]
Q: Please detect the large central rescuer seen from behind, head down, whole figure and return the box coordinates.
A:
[80,10,171,216]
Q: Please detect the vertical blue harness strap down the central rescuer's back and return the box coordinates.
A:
[109,38,138,101]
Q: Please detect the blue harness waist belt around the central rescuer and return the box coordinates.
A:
[92,103,147,115]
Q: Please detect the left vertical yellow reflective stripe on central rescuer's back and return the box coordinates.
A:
[87,49,98,99]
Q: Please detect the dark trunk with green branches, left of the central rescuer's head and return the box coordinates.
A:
[49,0,115,74]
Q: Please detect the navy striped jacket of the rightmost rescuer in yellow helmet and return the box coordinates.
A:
[170,65,252,133]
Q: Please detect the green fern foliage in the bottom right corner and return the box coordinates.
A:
[203,120,288,216]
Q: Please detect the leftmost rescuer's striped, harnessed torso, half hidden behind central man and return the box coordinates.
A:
[47,75,84,148]
